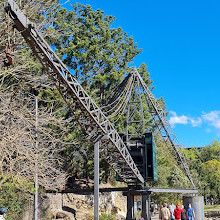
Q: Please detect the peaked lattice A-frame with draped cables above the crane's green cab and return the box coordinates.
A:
[104,68,196,189]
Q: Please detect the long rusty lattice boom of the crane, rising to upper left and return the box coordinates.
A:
[5,0,144,185]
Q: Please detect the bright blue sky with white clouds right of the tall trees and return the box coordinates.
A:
[62,0,220,147]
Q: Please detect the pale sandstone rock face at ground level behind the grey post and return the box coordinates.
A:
[47,192,127,220]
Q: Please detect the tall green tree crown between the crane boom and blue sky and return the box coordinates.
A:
[48,3,150,103]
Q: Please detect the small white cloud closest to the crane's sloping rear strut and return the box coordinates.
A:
[169,111,202,127]
